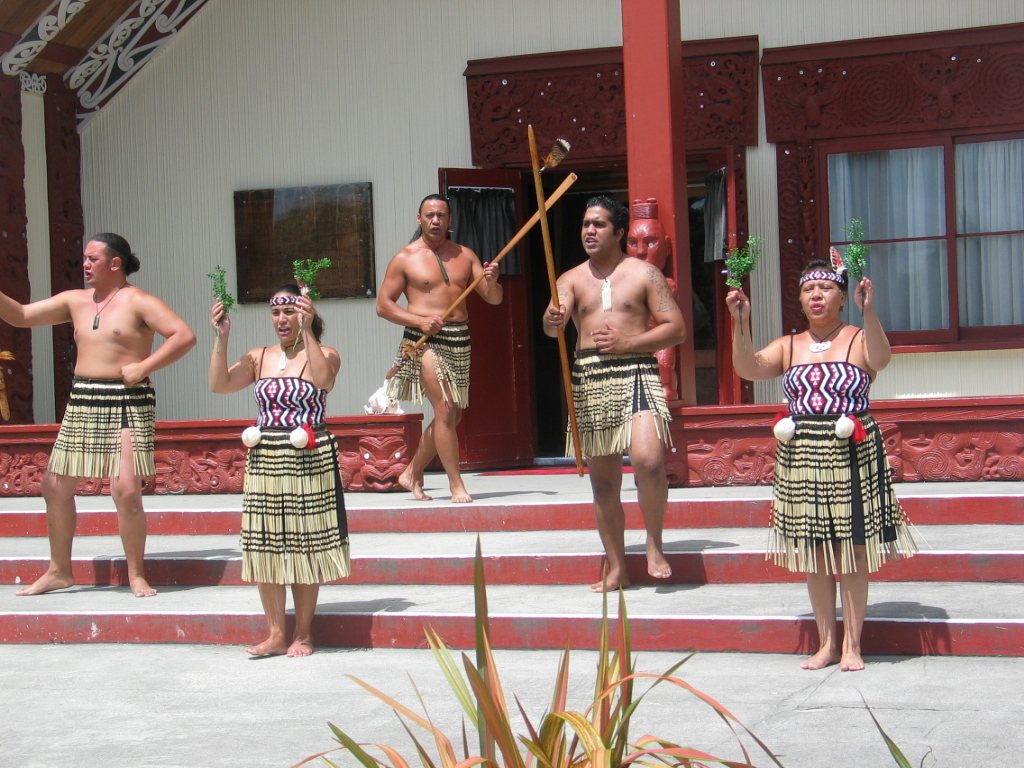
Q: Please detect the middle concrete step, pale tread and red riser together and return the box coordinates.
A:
[0,525,1024,586]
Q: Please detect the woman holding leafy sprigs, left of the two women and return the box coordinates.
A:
[210,286,349,656]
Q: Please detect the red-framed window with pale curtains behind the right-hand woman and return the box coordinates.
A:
[824,136,1024,344]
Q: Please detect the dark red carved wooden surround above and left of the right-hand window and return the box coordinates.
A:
[761,25,1024,332]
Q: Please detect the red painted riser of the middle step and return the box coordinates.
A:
[6,552,1024,587]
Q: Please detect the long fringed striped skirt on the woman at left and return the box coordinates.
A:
[242,425,350,584]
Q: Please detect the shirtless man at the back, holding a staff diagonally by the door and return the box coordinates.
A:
[377,195,503,503]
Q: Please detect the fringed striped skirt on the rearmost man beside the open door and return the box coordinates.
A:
[387,323,470,409]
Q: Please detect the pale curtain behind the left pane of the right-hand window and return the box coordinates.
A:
[828,146,949,331]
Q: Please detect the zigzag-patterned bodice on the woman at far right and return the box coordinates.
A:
[782,360,871,416]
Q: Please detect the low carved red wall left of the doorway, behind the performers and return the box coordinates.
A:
[0,414,423,497]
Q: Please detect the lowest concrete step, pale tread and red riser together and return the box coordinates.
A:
[0,583,1024,655]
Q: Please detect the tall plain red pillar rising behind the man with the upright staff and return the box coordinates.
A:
[622,0,696,406]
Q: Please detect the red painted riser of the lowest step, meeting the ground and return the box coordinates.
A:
[0,613,1024,656]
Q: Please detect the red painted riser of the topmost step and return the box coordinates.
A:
[0,496,1024,537]
